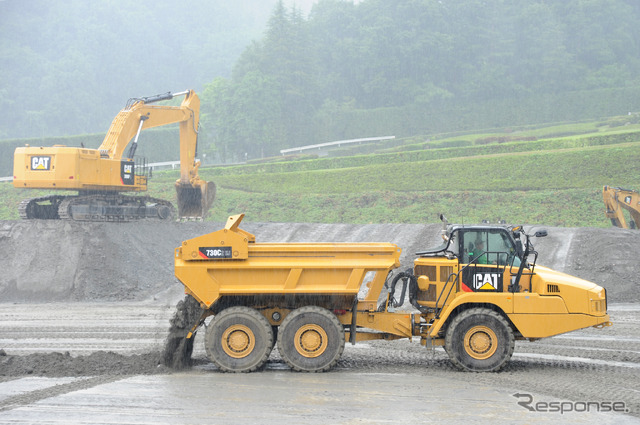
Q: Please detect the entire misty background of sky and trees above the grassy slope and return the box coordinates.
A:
[0,0,640,161]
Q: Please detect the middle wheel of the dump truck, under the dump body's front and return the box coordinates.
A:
[278,306,344,372]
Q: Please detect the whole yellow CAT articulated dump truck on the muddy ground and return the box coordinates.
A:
[175,214,611,372]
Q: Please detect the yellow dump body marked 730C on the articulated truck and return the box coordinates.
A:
[175,214,401,309]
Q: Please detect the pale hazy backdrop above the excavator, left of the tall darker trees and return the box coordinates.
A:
[0,0,275,139]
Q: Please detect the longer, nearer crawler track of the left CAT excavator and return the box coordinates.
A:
[58,194,176,222]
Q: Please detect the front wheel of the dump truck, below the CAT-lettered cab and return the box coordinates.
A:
[445,308,515,372]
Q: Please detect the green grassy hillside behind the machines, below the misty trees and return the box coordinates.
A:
[0,119,640,227]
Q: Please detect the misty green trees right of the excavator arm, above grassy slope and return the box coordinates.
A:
[202,0,640,161]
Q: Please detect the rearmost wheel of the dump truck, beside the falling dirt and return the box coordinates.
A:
[204,307,273,372]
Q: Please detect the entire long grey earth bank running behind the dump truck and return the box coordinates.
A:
[0,220,640,304]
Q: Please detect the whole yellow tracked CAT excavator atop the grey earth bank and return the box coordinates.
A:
[13,90,216,221]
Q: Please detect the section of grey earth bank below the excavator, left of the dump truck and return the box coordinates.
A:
[0,220,215,302]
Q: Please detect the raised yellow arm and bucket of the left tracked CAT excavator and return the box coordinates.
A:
[98,90,216,217]
